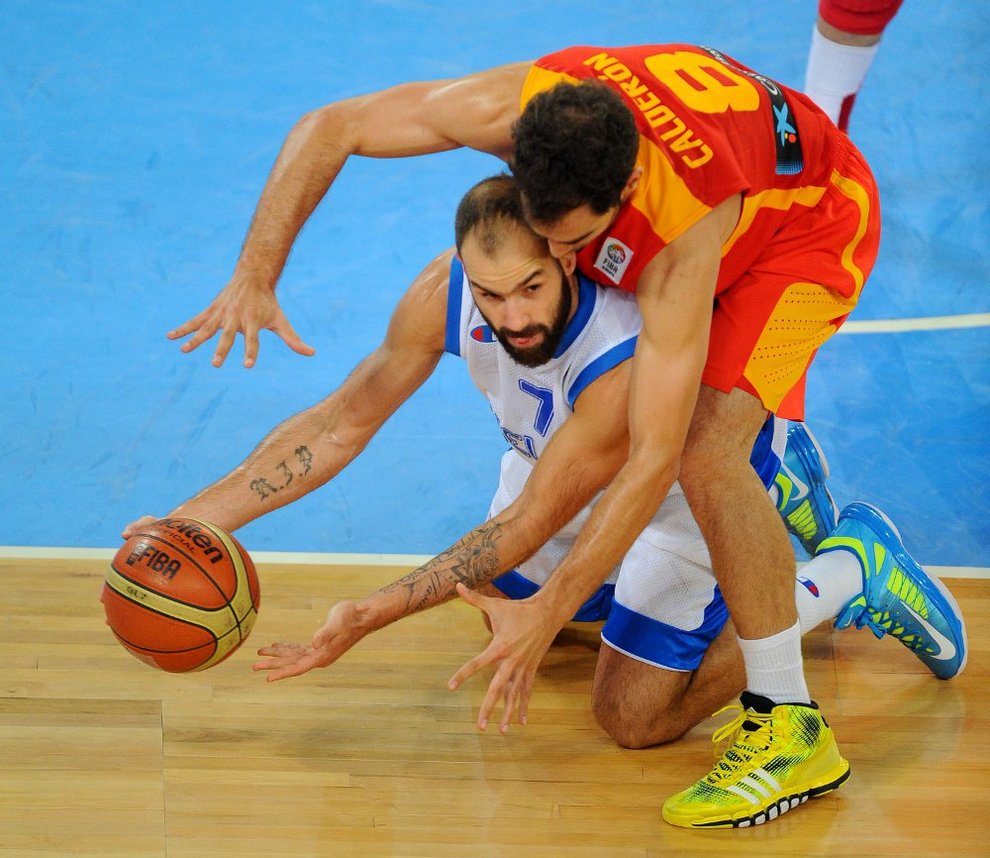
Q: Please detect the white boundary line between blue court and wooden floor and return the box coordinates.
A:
[0,545,990,581]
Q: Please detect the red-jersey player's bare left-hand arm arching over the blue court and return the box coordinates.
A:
[168,63,530,367]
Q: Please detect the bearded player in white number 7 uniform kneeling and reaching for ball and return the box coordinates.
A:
[124,176,965,747]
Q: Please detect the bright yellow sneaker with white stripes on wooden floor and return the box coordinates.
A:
[663,692,849,828]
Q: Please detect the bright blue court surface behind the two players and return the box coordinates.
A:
[0,6,990,567]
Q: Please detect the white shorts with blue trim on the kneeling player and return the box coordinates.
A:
[489,418,787,671]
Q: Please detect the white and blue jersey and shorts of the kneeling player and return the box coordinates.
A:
[445,252,786,670]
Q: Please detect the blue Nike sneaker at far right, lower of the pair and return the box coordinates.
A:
[818,502,968,679]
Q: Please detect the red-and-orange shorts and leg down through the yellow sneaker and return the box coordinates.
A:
[663,144,879,827]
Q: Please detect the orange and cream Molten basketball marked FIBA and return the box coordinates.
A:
[101,518,261,673]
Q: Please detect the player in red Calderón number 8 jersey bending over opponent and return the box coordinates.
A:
[170,45,879,827]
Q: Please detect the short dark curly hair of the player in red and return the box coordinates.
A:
[512,81,639,223]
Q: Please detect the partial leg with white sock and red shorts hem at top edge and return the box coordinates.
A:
[804,0,902,131]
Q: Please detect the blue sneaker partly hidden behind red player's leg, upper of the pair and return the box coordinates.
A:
[774,422,839,557]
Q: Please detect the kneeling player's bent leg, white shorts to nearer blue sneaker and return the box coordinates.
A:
[592,494,967,748]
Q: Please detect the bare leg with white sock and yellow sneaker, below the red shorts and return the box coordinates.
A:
[680,400,849,827]
